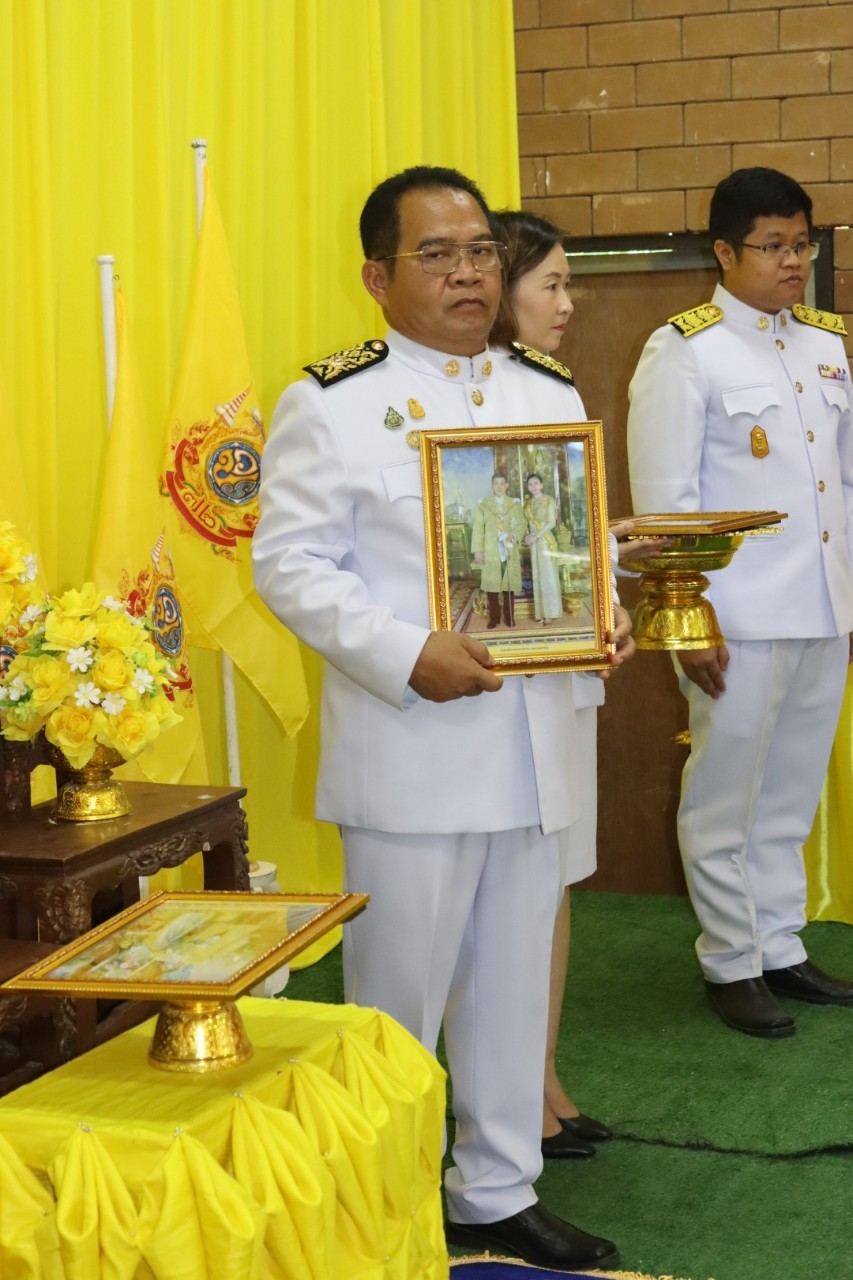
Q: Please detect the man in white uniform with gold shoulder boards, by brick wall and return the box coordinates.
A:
[628,169,853,1037]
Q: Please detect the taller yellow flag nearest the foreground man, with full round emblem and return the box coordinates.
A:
[161,170,309,736]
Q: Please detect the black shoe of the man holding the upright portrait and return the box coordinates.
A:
[446,1203,619,1271]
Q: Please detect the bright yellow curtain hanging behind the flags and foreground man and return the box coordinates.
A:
[0,0,519,942]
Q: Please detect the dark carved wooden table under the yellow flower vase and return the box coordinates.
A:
[0,782,250,942]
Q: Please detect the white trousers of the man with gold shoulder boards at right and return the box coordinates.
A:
[676,636,848,982]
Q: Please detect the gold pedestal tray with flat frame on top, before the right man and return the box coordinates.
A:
[615,511,785,650]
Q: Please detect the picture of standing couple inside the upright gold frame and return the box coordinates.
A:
[442,440,594,640]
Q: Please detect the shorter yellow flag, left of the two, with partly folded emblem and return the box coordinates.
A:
[92,289,207,783]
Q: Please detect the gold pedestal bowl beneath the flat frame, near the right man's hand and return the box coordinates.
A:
[624,531,743,649]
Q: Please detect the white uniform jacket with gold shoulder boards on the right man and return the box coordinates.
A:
[628,285,853,640]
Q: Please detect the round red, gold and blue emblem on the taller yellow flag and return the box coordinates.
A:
[161,385,265,559]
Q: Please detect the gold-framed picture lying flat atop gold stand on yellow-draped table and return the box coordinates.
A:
[3,892,368,1002]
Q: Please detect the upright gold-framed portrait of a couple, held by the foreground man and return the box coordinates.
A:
[420,422,613,675]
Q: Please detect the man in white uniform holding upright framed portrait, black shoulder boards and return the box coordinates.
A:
[254,166,633,1268]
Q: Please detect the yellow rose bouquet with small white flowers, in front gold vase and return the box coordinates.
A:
[0,582,181,769]
